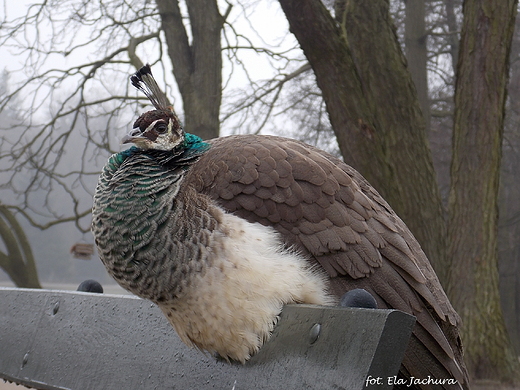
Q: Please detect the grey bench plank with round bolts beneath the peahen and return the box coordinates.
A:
[0,288,415,390]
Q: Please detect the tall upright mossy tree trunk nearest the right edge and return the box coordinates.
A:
[448,0,520,381]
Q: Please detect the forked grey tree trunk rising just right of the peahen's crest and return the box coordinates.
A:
[152,0,224,139]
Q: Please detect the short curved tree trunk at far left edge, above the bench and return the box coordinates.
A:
[0,206,41,288]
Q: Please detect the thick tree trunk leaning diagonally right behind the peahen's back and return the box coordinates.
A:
[280,0,446,282]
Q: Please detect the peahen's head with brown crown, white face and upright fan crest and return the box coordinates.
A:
[121,64,185,150]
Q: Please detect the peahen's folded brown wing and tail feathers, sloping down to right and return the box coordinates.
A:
[187,135,464,382]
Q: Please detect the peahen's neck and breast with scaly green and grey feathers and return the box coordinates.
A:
[92,136,216,301]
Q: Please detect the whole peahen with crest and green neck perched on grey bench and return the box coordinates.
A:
[92,65,469,389]
